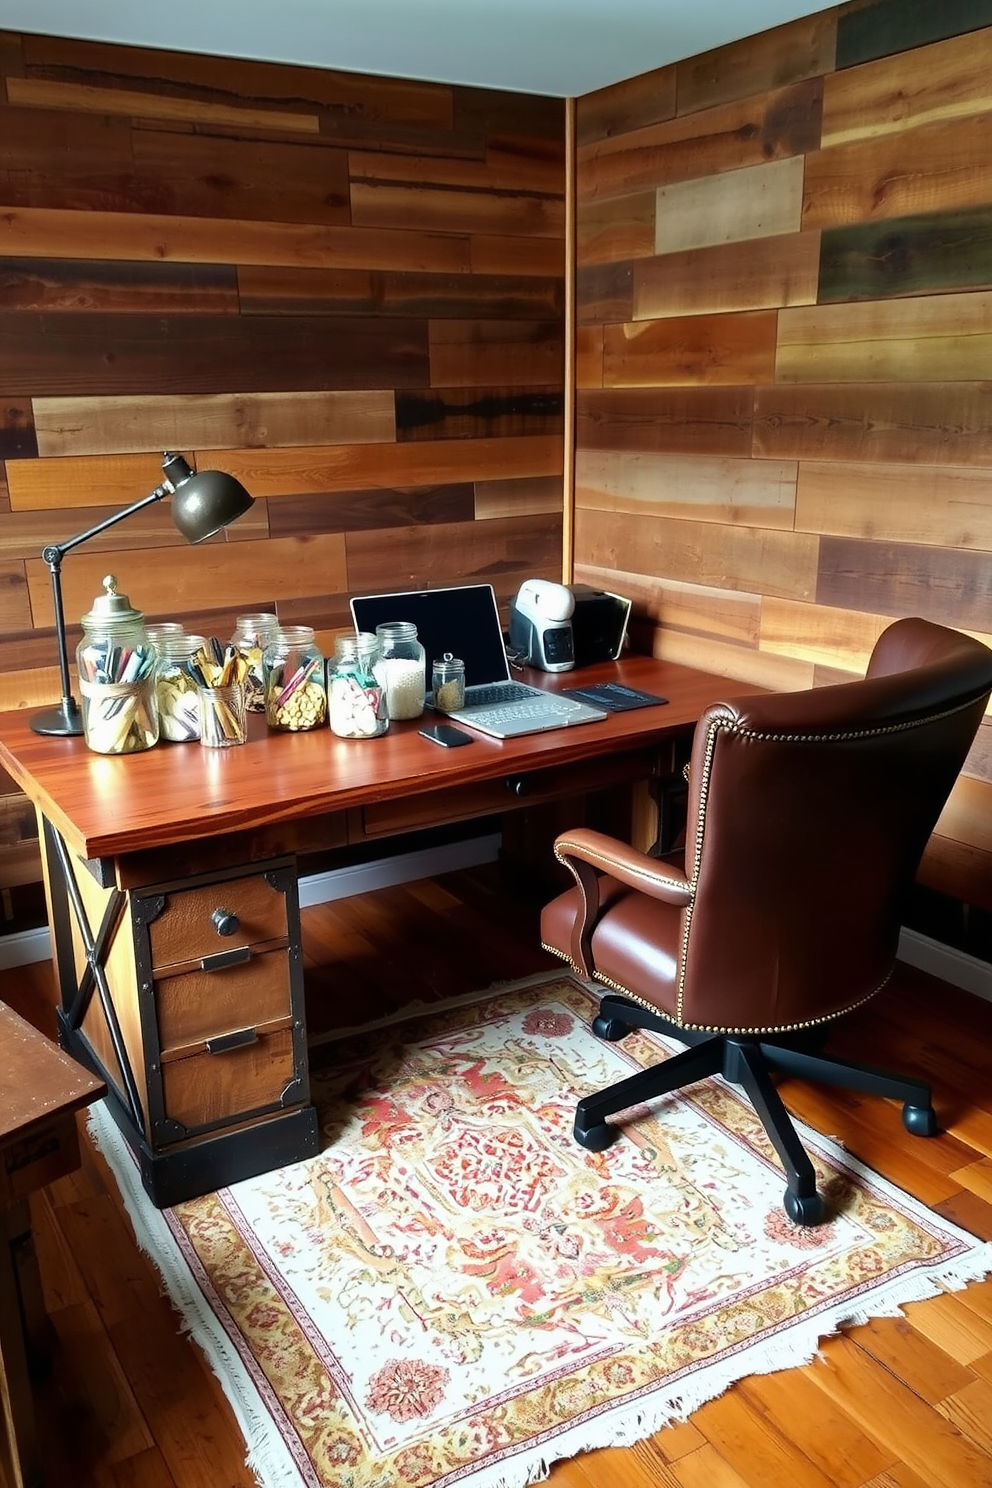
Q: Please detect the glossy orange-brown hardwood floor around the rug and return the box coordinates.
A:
[0,869,992,1488]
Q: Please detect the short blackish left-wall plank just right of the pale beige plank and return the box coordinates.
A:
[396,387,564,443]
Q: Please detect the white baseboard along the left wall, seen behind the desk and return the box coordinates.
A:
[0,832,501,972]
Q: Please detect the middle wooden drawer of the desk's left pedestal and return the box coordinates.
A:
[155,948,292,1058]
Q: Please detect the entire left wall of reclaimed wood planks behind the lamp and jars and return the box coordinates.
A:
[0,33,565,744]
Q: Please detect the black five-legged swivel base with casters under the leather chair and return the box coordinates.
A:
[573,995,937,1225]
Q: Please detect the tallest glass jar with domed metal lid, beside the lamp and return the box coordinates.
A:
[76,574,159,754]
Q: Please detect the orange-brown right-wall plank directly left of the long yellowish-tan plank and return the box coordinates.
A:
[602,310,776,387]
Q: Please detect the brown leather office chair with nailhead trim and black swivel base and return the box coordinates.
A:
[541,619,992,1225]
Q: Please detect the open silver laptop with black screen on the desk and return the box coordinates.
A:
[351,583,608,740]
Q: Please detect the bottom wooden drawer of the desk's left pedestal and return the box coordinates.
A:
[162,1028,297,1140]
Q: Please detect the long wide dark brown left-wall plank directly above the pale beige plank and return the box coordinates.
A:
[0,311,430,397]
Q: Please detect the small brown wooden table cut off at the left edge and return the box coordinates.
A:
[0,1003,104,1488]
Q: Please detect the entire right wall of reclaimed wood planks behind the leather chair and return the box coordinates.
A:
[574,0,992,909]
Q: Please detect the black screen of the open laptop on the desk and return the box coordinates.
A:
[351,583,510,690]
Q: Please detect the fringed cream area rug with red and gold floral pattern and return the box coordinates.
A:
[92,975,992,1488]
